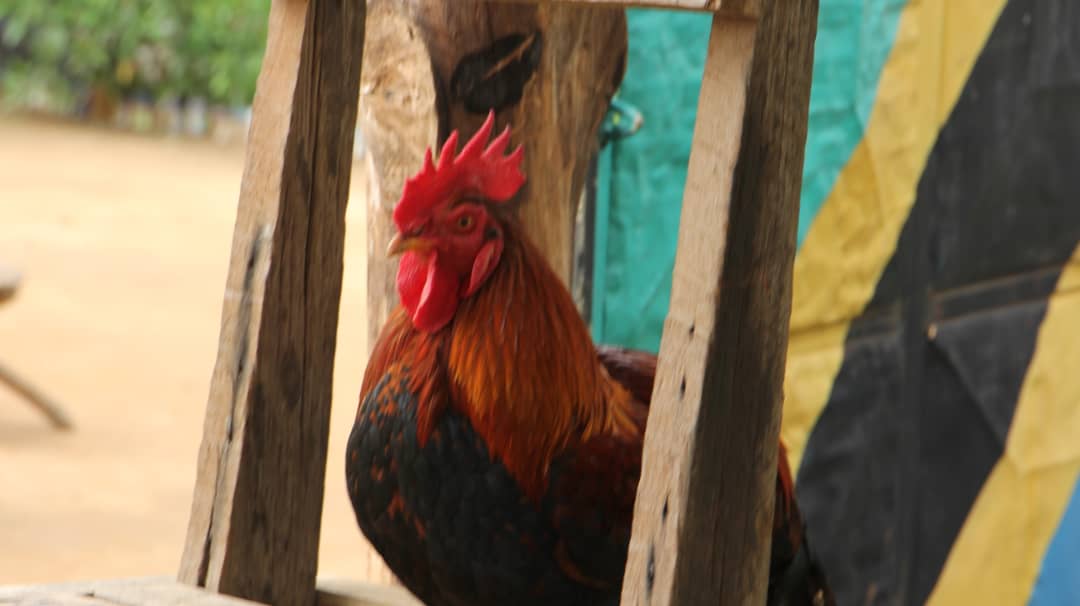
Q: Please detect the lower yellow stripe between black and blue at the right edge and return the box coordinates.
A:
[929,243,1080,606]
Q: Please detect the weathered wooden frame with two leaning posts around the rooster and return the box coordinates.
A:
[0,0,818,606]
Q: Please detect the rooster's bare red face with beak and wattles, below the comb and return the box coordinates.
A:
[389,200,503,333]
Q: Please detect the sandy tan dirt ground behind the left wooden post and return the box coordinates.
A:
[0,117,388,583]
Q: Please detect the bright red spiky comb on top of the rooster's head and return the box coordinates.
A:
[394,111,525,230]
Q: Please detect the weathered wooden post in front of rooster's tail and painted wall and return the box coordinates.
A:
[622,0,818,606]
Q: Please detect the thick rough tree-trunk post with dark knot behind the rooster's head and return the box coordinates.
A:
[361,0,626,344]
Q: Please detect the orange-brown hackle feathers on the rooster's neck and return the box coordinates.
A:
[365,221,640,499]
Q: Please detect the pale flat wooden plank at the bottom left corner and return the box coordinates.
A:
[0,577,255,606]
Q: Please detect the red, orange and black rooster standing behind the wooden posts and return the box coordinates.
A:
[346,113,833,606]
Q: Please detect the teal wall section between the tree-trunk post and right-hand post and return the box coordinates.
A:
[593,10,710,351]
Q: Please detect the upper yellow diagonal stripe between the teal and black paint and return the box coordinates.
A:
[782,0,1005,470]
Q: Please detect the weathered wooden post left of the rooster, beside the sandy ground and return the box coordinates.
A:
[179,0,365,605]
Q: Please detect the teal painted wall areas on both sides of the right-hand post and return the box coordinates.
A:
[593,0,906,351]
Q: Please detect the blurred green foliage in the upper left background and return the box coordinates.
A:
[0,0,270,109]
